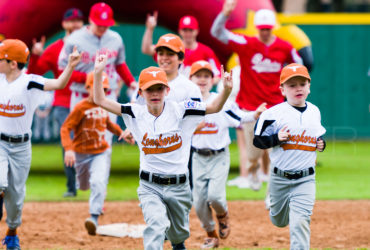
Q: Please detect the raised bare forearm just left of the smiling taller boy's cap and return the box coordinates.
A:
[141,11,158,56]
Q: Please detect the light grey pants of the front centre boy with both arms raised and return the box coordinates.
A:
[137,176,192,250]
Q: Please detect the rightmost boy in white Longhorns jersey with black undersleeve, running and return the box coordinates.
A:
[253,63,326,249]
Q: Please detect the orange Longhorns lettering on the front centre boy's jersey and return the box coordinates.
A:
[141,133,182,155]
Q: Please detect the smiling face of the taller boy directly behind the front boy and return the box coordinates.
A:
[157,48,182,75]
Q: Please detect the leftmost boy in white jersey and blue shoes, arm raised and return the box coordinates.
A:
[0,39,81,249]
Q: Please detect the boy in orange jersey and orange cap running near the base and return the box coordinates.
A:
[60,72,123,235]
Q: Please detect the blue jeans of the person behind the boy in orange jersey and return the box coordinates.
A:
[53,106,76,194]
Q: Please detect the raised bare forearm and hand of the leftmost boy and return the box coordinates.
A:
[44,47,81,91]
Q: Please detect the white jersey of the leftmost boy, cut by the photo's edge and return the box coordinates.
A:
[0,73,48,135]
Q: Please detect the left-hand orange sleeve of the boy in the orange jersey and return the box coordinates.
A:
[60,105,84,151]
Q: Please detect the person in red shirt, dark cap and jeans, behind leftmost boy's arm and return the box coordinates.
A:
[28,8,86,197]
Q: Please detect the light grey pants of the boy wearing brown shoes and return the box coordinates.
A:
[192,147,230,232]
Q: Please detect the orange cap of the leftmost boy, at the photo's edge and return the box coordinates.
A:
[0,39,30,63]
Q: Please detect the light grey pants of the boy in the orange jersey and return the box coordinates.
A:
[75,150,110,215]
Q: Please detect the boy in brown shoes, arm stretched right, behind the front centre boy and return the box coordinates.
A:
[190,61,266,249]
